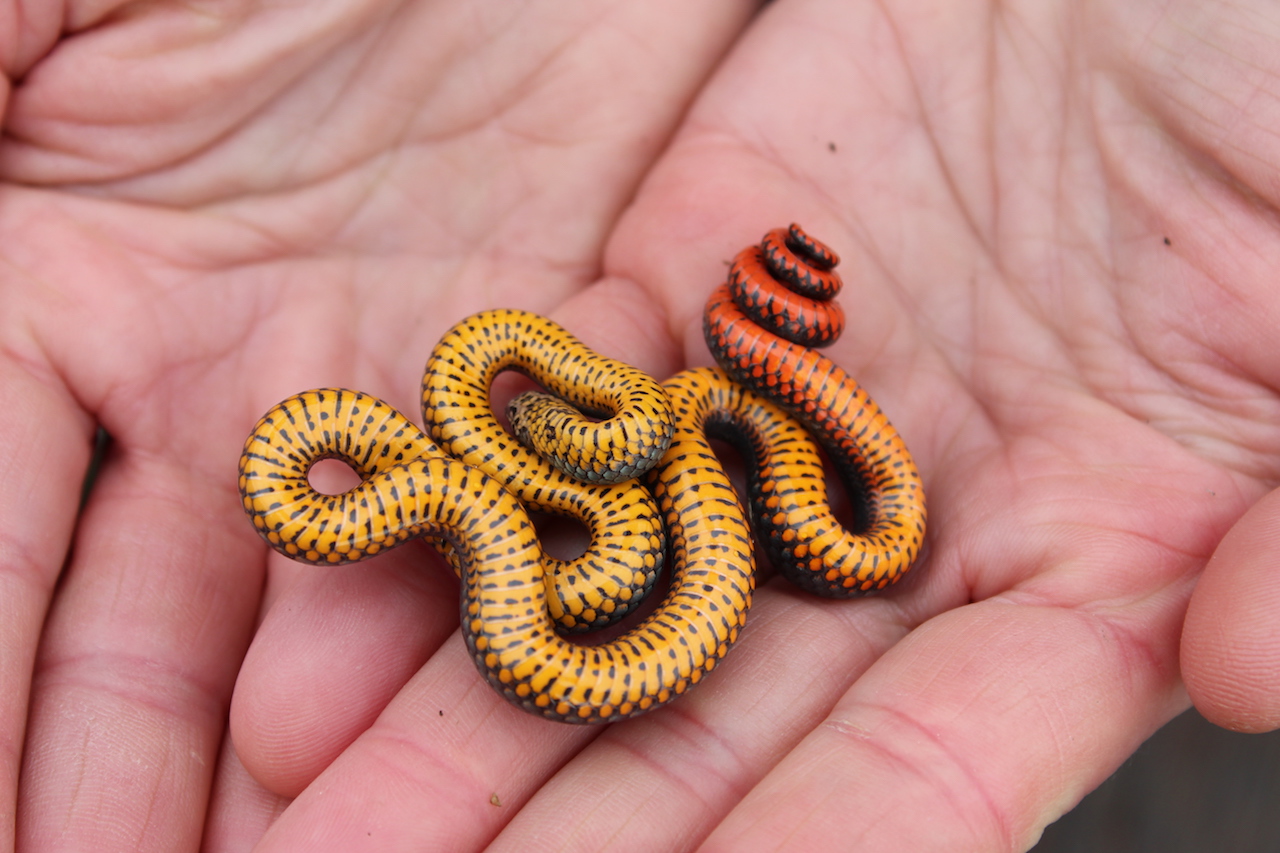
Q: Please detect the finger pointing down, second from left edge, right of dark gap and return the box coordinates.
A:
[18,450,261,850]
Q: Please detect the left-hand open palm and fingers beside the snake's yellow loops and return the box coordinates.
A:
[0,3,750,850]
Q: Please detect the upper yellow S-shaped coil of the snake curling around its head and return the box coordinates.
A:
[422,310,675,631]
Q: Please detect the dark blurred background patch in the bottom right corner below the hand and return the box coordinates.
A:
[1032,710,1280,853]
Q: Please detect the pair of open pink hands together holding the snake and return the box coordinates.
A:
[0,0,1280,852]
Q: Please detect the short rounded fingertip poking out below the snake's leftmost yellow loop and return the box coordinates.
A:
[230,540,458,797]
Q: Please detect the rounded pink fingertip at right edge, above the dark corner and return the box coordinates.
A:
[1181,492,1280,731]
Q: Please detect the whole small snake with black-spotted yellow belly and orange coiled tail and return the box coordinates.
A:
[239,225,924,722]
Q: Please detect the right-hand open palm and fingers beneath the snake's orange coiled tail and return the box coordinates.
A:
[232,3,1277,850]
